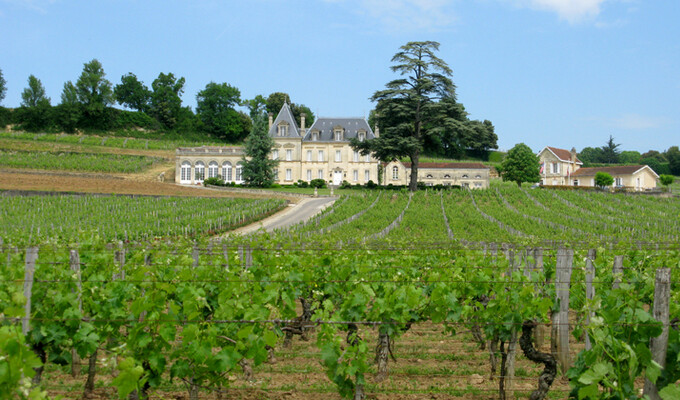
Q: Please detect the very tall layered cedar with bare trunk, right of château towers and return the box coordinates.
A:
[351,41,456,191]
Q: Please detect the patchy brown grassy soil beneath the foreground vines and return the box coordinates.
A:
[39,323,580,400]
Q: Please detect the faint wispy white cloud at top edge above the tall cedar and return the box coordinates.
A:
[326,0,456,32]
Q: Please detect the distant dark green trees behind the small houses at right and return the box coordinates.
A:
[578,136,680,176]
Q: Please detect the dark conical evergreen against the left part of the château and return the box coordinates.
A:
[243,115,279,187]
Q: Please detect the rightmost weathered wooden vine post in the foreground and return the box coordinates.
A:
[644,268,671,400]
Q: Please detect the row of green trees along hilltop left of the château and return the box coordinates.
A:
[0,59,314,143]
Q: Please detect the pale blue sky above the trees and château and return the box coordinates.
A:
[0,0,680,152]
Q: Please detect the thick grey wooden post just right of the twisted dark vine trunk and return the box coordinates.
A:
[552,248,574,374]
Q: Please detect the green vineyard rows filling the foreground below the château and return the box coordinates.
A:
[0,185,680,400]
